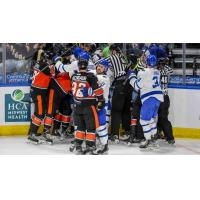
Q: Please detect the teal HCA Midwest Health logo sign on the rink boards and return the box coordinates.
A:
[5,89,31,122]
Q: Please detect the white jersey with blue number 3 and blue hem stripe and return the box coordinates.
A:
[130,68,163,103]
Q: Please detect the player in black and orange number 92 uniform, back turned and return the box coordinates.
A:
[71,52,105,154]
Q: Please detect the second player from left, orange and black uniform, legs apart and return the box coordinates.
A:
[44,56,72,141]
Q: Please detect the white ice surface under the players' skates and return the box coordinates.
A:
[0,136,200,155]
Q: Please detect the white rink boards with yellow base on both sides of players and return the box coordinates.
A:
[0,86,200,138]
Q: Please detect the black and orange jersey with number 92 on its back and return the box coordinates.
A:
[71,72,103,106]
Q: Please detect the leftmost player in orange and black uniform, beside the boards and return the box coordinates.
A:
[28,50,54,143]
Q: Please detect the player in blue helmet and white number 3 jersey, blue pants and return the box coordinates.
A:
[129,55,163,148]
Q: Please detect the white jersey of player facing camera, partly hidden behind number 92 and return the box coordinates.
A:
[89,70,110,103]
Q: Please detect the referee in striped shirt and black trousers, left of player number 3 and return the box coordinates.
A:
[108,44,132,143]
